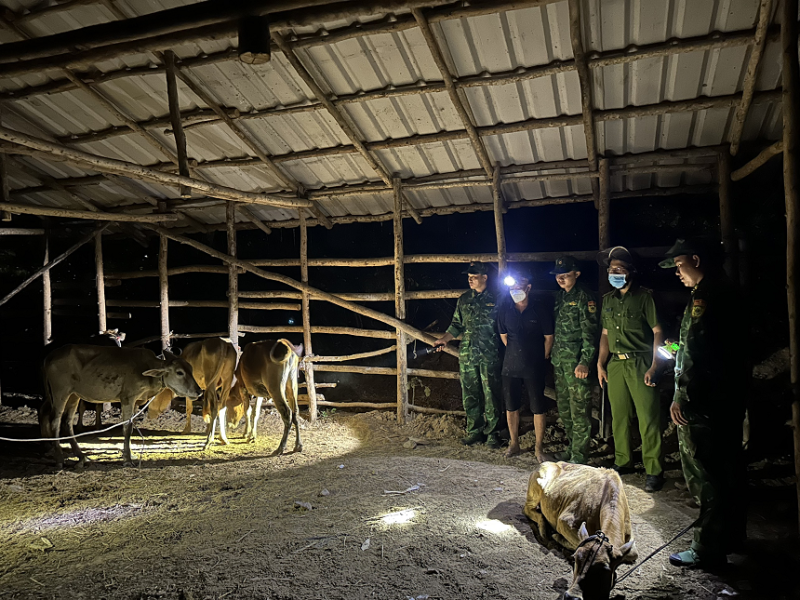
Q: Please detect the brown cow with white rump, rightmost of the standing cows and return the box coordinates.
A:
[238,339,303,456]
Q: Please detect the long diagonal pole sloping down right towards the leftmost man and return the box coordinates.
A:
[144,225,457,356]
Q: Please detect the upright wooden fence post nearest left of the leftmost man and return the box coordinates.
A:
[392,177,408,424]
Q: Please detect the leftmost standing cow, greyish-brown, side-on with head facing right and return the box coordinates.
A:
[39,345,201,468]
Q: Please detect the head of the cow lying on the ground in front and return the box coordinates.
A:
[564,523,638,600]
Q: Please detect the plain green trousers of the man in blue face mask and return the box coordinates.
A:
[607,352,663,475]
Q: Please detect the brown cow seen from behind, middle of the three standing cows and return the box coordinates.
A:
[148,338,236,450]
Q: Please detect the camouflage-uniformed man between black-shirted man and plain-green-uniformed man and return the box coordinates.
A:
[550,256,597,464]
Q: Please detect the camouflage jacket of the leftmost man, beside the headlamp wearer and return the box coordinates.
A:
[447,289,500,363]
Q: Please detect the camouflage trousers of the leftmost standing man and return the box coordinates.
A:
[458,360,505,435]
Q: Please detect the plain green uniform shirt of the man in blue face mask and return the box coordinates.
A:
[601,282,658,354]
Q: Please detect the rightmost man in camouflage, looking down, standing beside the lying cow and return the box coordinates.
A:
[661,240,750,567]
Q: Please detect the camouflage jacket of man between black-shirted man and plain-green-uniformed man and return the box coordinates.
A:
[552,283,597,367]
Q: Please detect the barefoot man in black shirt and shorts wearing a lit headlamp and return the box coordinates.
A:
[497,270,554,462]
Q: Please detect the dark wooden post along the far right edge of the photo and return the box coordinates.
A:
[781,0,800,536]
